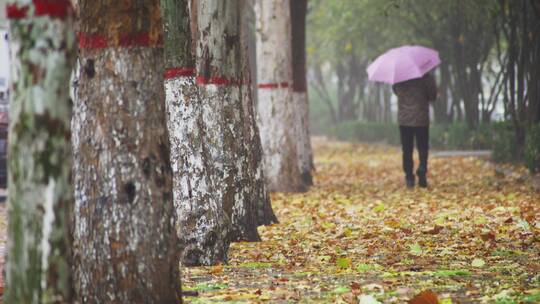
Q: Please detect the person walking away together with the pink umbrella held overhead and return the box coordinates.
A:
[367,45,441,188]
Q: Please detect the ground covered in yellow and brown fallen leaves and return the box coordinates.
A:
[183,140,540,303]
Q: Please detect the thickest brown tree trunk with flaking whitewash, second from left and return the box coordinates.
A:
[72,0,180,303]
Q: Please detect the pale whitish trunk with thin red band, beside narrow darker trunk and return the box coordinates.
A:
[255,0,306,192]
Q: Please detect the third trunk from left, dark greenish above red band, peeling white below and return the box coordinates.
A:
[161,0,232,266]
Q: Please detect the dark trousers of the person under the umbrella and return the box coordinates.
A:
[399,126,429,180]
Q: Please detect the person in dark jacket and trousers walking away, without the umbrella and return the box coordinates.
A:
[392,73,437,188]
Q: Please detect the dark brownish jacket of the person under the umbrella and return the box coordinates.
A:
[392,73,437,127]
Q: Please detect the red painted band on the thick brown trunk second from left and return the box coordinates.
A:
[77,33,162,49]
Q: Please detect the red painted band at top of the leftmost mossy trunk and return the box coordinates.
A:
[6,0,71,19]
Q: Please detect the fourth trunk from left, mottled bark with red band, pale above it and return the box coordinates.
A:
[196,0,269,245]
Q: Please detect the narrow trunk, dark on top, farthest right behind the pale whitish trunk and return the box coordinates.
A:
[290,0,314,186]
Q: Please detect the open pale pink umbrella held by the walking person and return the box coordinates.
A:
[367,45,441,84]
